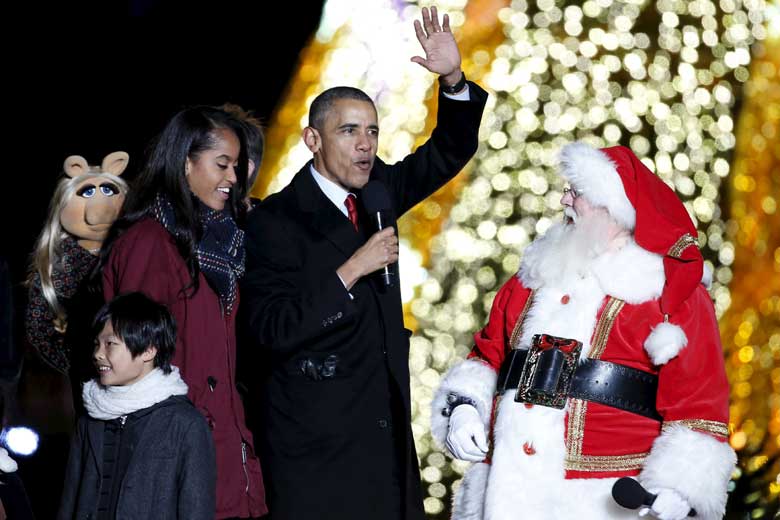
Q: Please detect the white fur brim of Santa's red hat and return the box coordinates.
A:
[560,141,636,229]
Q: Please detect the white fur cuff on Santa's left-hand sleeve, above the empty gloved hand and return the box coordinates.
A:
[431,359,498,448]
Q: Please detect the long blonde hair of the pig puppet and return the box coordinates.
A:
[27,172,127,322]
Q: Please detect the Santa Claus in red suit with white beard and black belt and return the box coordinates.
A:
[432,142,736,520]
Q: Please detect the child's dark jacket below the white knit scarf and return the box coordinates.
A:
[58,396,216,520]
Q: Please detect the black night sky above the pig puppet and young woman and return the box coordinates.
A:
[0,0,322,280]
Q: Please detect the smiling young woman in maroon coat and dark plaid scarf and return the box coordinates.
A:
[102,107,267,519]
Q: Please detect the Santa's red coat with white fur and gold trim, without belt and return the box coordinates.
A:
[432,229,735,520]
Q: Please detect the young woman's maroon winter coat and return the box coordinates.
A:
[103,218,267,518]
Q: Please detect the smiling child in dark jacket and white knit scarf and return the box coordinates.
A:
[58,292,216,519]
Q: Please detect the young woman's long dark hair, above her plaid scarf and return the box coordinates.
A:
[99,106,247,290]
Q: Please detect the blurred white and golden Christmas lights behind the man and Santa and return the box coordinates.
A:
[255,0,780,518]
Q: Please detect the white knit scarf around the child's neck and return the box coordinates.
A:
[82,367,187,420]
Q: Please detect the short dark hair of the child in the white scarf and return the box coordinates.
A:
[92,292,176,374]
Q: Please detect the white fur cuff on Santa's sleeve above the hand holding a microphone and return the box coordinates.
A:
[639,425,737,520]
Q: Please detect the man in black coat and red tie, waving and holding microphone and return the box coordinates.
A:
[242,8,487,520]
